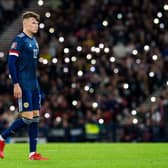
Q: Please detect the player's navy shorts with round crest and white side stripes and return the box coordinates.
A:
[18,89,41,112]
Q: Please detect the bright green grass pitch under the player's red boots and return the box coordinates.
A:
[0,143,168,168]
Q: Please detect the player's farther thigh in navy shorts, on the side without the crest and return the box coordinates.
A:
[32,89,41,116]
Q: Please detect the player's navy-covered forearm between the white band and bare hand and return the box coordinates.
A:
[8,56,18,84]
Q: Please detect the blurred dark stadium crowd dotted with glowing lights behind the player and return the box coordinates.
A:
[0,0,168,142]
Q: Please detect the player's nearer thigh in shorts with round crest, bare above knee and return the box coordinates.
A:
[18,89,33,119]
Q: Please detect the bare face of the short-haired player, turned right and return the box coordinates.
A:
[23,17,39,34]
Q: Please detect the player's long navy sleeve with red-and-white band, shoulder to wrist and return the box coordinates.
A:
[8,38,22,84]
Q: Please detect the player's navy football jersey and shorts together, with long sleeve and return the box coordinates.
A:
[8,32,41,112]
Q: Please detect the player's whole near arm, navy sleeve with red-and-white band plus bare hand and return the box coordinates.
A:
[8,38,22,98]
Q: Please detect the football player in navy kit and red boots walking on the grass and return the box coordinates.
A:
[0,11,48,160]
